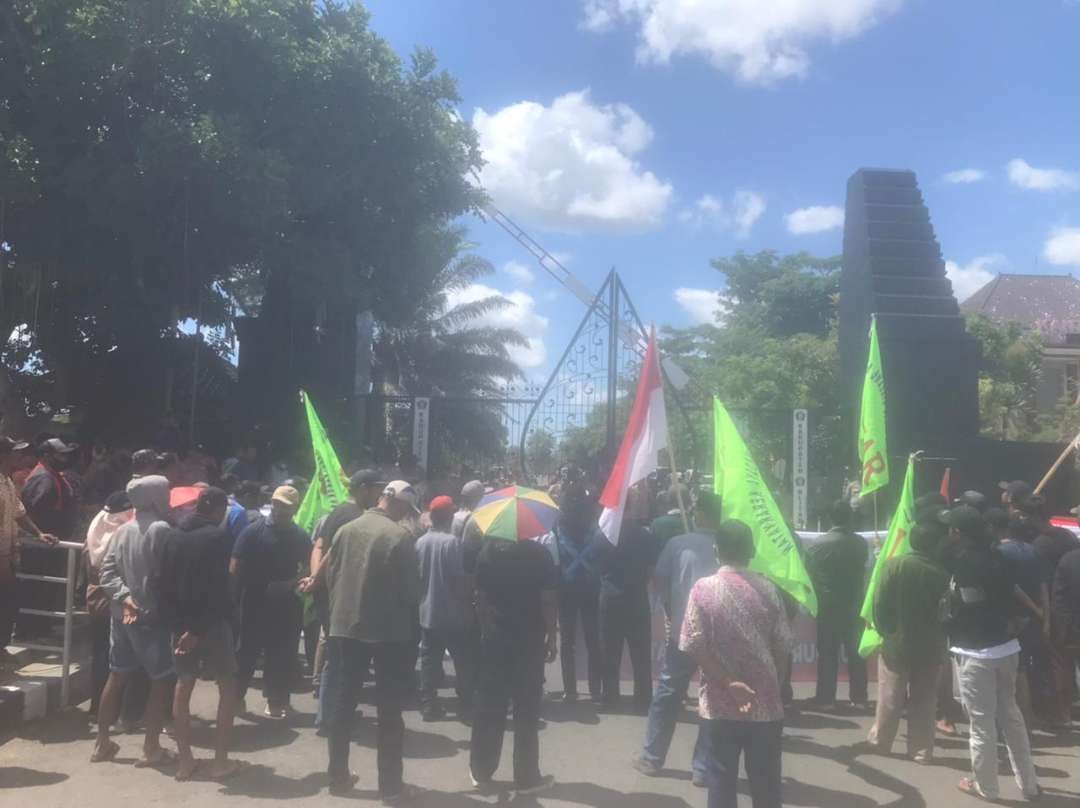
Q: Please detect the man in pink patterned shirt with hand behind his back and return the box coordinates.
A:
[679,521,792,808]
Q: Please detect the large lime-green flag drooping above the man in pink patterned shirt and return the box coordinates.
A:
[713,399,818,615]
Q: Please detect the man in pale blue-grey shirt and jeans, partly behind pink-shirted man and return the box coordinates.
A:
[633,491,720,787]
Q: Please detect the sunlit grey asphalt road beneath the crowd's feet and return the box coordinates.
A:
[0,669,1080,808]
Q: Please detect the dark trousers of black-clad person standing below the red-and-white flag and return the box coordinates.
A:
[600,590,652,710]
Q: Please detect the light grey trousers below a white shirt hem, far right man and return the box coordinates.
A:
[956,654,1039,799]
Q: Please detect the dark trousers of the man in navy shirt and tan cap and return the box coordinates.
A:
[237,597,301,708]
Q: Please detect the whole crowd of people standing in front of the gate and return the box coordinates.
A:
[0,436,1080,808]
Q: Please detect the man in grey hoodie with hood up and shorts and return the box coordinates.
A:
[90,475,173,766]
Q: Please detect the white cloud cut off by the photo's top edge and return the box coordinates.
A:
[582,0,901,83]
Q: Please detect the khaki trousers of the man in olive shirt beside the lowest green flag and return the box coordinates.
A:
[867,657,942,760]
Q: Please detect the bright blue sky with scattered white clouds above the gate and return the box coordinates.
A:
[365,0,1080,377]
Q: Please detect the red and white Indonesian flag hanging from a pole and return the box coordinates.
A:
[599,328,667,544]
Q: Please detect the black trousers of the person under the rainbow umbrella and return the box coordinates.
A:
[469,637,543,789]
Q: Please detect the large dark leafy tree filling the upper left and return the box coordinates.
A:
[0,0,480,442]
